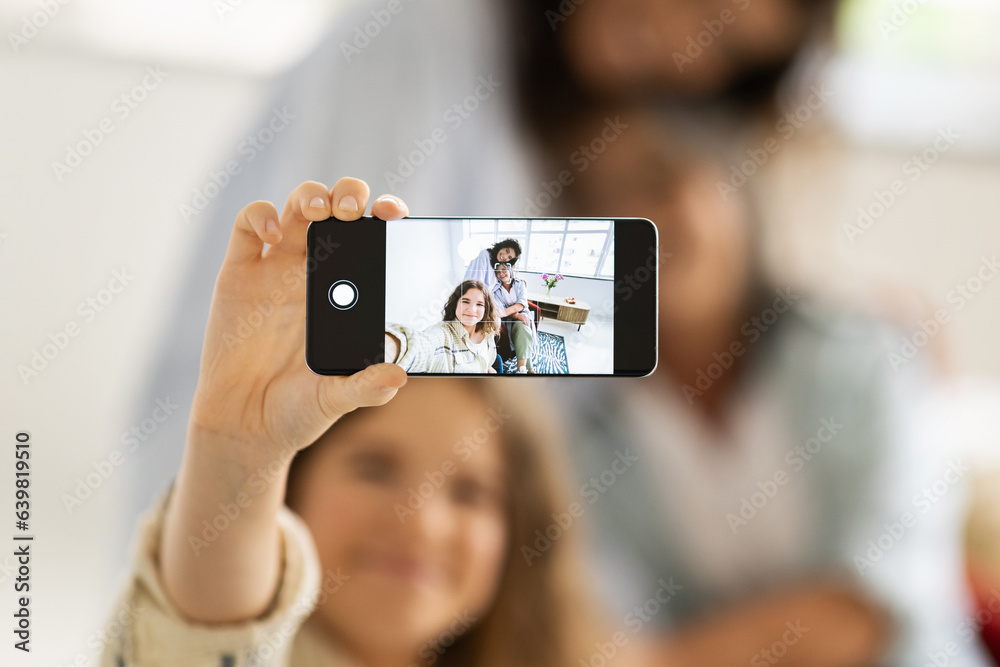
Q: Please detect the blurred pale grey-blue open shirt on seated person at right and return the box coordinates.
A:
[546,304,988,667]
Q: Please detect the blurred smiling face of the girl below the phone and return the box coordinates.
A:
[297,380,508,662]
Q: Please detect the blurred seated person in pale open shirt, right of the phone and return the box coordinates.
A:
[554,108,988,667]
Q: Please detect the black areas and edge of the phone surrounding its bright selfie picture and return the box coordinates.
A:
[305,216,659,378]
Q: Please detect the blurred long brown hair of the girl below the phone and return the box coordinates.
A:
[286,378,613,667]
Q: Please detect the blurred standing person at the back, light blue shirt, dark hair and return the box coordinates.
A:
[136,0,833,480]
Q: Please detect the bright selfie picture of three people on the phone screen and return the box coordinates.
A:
[385,218,615,375]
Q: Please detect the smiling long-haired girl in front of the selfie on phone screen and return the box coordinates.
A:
[385,280,500,373]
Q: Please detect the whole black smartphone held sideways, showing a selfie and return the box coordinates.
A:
[305,217,659,377]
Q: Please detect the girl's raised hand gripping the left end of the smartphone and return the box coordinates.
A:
[189,178,408,461]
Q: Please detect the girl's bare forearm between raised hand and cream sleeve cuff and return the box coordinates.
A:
[160,428,291,622]
